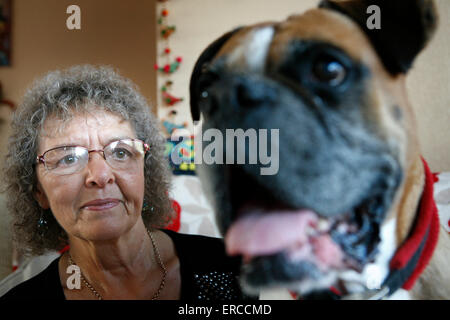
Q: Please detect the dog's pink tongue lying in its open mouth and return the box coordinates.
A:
[225,210,318,256]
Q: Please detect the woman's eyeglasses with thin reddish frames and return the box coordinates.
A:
[36,139,150,175]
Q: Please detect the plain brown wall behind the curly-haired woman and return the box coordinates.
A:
[0,0,156,279]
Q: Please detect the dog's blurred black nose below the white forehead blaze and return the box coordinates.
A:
[233,77,276,108]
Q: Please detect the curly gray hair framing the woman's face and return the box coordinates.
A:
[4,65,173,255]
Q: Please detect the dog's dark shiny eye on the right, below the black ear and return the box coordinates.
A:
[312,55,347,86]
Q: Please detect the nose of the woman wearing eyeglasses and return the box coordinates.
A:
[86,152,115,188]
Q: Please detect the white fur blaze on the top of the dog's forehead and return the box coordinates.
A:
[228,27,275,72]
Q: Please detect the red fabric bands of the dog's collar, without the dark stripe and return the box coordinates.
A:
[390,159,439,290]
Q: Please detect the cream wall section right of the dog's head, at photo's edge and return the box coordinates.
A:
[407,0,450,172]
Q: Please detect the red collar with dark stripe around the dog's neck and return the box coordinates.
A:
[385,158,440,293]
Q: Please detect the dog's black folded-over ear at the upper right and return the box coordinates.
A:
[319,0,438,75]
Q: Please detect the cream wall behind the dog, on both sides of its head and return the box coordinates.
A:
[158,0,450,171]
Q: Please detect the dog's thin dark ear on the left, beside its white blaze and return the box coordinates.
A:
[189,27,242,121]
